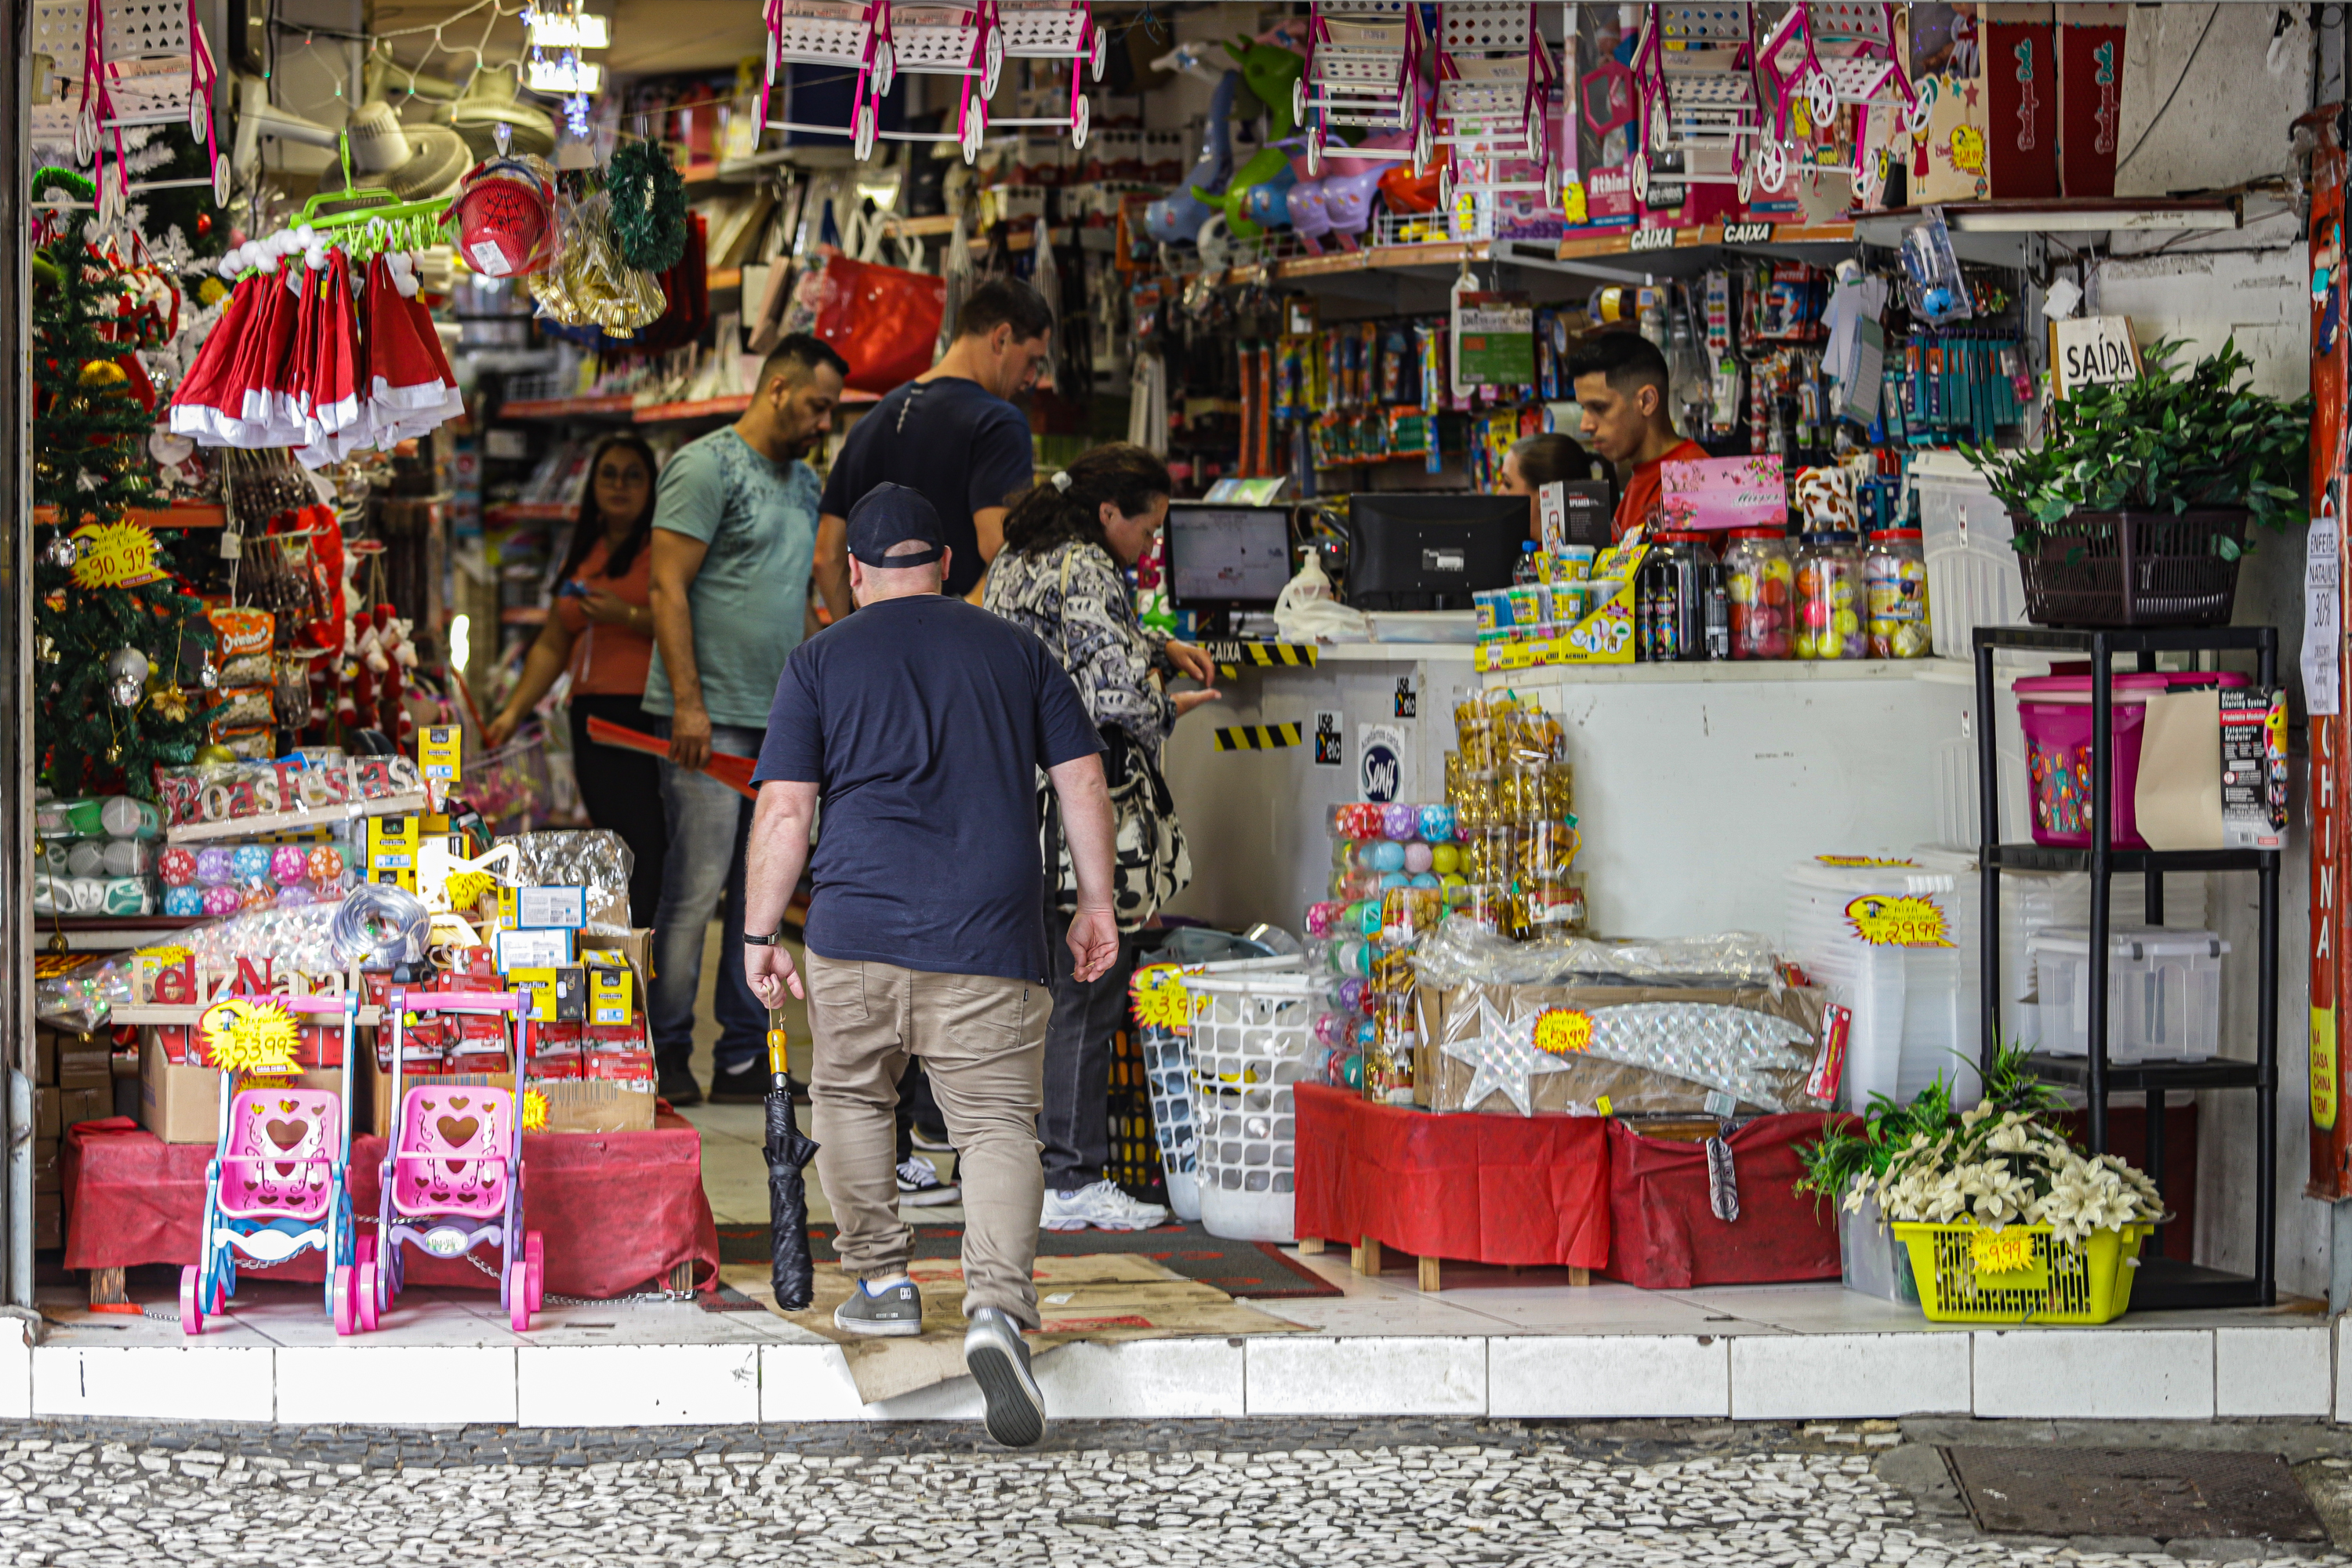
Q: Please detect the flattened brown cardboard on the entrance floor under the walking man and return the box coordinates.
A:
[720,1253,1308,1403]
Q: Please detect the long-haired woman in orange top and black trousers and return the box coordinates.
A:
[482,435,670,926]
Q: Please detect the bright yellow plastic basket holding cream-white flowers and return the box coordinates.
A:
[1896,1220,2150,1323]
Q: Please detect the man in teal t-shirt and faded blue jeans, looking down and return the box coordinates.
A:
[644,334,849,1105]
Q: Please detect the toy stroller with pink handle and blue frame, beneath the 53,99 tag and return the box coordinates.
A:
[179,994,360,1333]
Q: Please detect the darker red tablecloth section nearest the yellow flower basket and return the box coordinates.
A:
[1606,1114,1837,1290]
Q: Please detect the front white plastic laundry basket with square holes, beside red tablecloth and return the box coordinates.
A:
[1185,959,1322,1241]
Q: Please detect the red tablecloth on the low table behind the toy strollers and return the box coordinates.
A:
[61,1112,720,1298]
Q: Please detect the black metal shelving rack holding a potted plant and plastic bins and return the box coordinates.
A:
[1976,626,2281,1312]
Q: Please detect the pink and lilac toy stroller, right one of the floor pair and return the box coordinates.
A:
[360,987,546,1333]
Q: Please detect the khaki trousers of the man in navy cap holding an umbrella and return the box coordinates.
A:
[807,952,1054,1328]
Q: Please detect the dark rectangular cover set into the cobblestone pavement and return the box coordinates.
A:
[1943,1448,2328,1542]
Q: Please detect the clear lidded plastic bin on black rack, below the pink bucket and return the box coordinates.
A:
[2032,926,2230,1062]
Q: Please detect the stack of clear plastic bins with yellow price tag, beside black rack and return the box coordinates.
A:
[1783,860,1983,1109]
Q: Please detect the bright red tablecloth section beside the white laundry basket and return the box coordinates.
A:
[1296,1083,1618,1274]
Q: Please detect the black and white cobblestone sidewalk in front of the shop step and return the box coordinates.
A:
[0,1422,2352,1568]
